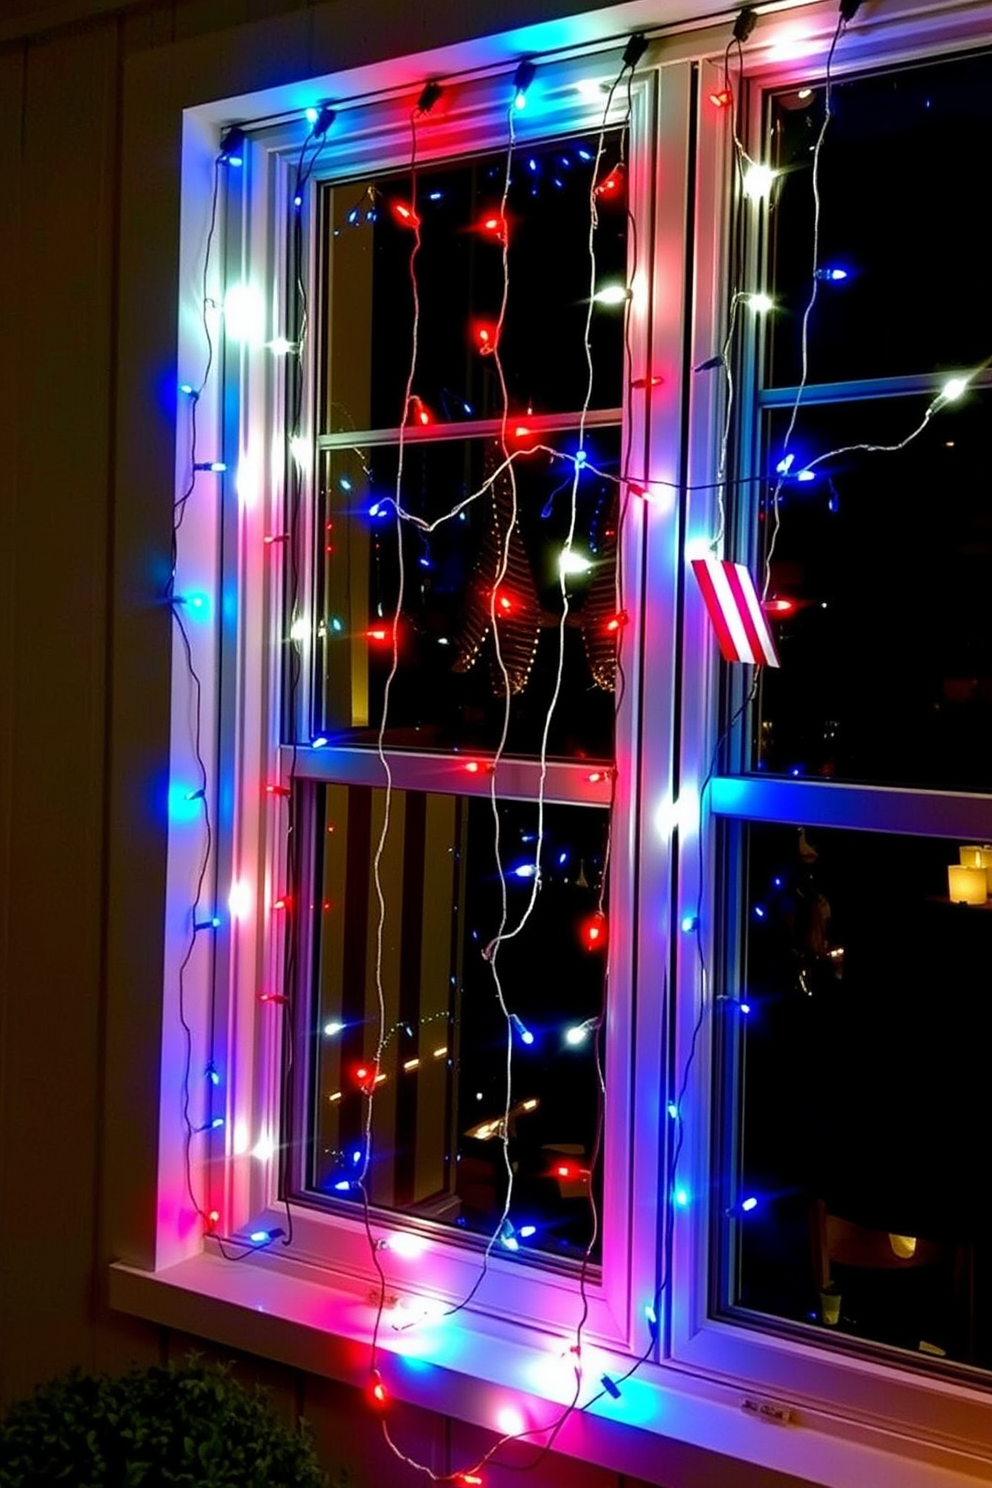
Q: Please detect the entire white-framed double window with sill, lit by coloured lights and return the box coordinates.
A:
[115,0,992,1488]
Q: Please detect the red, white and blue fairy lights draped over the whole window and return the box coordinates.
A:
[165,0,992,1485]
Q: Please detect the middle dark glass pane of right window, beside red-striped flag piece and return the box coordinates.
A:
[757,393,992,790]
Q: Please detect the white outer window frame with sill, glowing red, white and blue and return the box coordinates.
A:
[112,0,992,1488]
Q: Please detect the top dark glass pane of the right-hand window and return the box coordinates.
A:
[769,54,992,387]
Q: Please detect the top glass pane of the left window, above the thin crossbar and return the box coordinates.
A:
[324,134,626,432]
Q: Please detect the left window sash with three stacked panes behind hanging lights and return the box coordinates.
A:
[184,49,689,1345]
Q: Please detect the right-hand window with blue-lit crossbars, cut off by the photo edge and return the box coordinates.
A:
[714,23,992,1370]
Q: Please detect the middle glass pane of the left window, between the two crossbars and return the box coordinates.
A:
[315,430,619,759]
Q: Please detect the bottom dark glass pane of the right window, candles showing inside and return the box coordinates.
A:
[726,826,992,1369]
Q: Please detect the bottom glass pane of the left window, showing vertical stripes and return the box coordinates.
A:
[312,786,608,1259]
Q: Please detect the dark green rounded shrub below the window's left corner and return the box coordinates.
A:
[0,1360,324,1488]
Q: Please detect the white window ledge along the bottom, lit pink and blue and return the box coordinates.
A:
[110,1254,991,1488]
